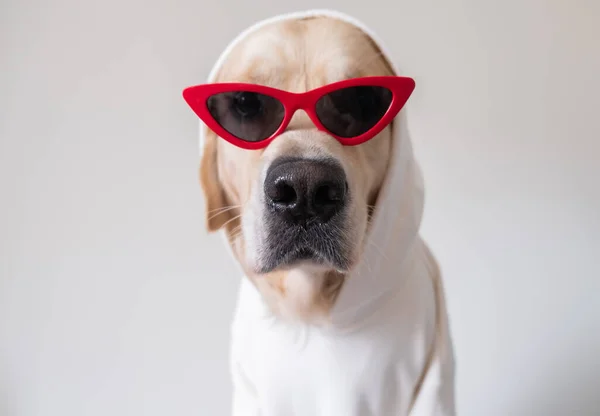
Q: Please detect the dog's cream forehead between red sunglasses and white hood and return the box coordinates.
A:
[230,18,378,88]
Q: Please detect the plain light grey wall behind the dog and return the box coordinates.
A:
[0,0,600,416]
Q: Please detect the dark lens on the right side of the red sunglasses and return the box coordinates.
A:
[315,86,392,137]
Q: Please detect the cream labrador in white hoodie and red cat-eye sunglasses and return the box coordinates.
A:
[184,11,455,416]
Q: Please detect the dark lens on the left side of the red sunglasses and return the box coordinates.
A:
[207,91,285,142]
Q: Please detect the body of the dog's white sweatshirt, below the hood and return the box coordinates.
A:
[231,240,455,416]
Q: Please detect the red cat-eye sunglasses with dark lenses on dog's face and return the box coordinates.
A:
[183,76,415,149]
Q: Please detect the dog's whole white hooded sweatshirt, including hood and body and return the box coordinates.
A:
[200,10,455,416]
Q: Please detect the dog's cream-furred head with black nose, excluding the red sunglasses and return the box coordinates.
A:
[195,17,406,320]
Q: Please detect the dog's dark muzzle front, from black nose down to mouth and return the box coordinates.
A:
[262,158,350,272]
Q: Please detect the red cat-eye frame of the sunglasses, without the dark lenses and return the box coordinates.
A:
[183,76,415,150]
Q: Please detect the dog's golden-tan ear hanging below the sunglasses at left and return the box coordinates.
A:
[200,132,233,232]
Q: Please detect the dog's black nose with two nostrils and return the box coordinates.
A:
[264,158,347,224]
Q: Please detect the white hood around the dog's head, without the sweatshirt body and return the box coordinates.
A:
[200,10,424,327]
